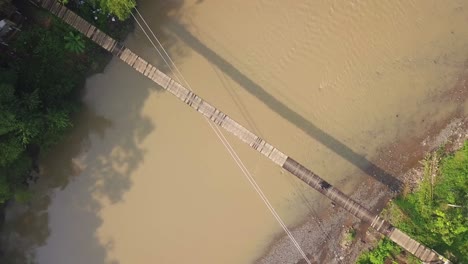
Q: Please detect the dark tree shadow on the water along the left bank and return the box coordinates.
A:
[0,1,187,264]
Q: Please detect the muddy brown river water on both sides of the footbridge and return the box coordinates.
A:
[1,0,468,264]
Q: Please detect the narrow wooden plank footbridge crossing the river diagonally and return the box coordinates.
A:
[36,0,447,263]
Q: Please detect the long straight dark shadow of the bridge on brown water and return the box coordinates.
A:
[166,21,402,191]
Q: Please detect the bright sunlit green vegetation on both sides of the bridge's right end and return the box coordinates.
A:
[358,141,468,263]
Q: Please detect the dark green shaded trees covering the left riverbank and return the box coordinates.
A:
[0,0,132,204]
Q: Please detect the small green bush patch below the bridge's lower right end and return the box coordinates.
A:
[356,239,401,264]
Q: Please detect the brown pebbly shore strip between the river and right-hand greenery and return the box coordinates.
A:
[257,83,468,264]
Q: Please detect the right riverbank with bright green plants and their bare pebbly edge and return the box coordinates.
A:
[358,129,468,263]
